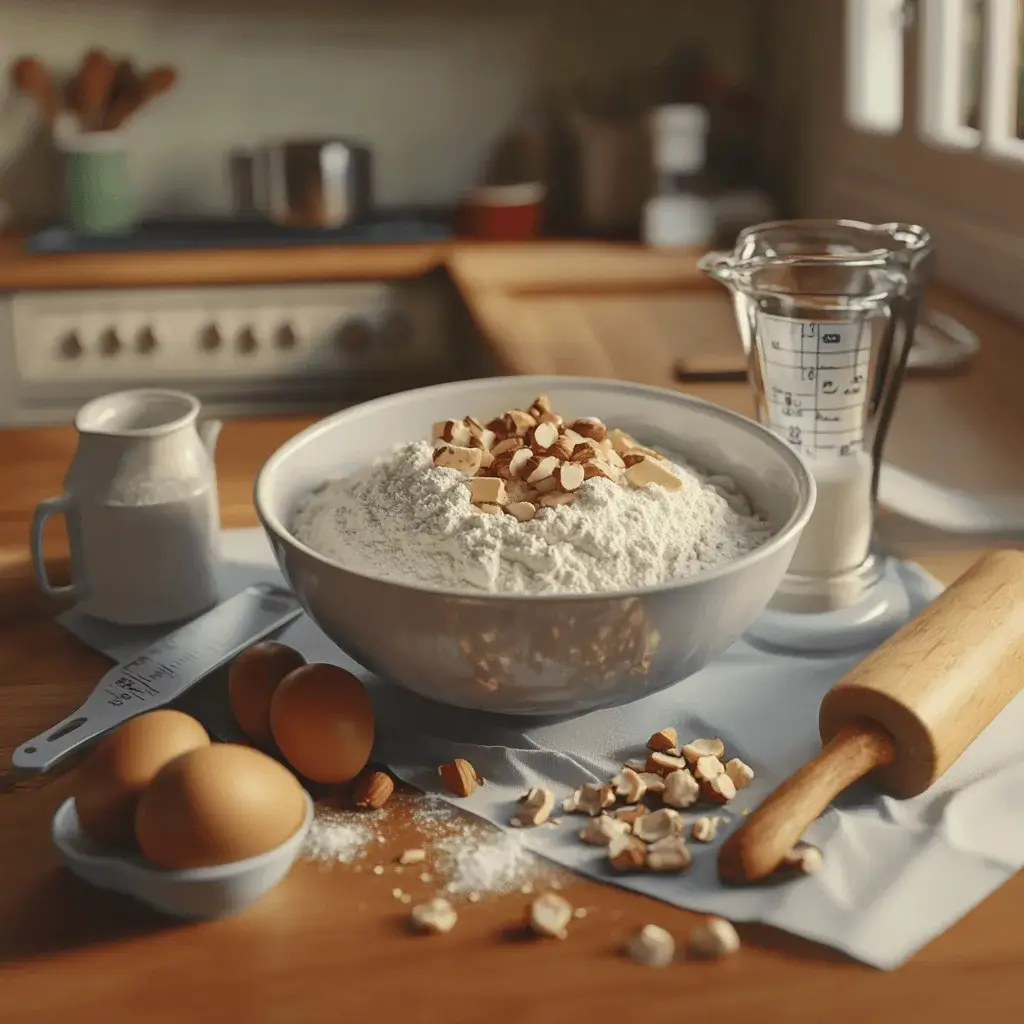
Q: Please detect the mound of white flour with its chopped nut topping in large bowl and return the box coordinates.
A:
[293,395,774,594]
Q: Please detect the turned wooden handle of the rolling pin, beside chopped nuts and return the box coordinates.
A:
[718,719,896,885]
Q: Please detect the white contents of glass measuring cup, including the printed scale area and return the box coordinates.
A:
[757,312,873,574]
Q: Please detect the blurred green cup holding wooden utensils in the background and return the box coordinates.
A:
[63,132,135,234]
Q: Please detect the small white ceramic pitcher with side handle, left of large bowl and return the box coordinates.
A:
[31,388,220,626]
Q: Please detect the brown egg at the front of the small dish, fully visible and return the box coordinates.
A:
[135,743,306,869]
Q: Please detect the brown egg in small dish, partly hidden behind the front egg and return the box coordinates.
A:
[75,709,210,846]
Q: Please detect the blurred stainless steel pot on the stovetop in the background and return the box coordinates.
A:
[231,138,373,227]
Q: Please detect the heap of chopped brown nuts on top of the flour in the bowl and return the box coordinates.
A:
[431,395,682,516]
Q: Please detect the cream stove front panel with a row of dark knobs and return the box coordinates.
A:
[0,274,466,426]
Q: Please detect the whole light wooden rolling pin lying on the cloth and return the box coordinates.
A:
[718,551,1024,884]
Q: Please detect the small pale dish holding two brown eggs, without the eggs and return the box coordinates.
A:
[51,792,313,921]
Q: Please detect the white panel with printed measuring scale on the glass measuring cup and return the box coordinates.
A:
[757,313,870,456]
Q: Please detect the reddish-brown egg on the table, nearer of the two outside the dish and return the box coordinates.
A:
[270,665,374,782]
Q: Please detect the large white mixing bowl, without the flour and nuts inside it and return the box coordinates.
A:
[255,377,815,715]
